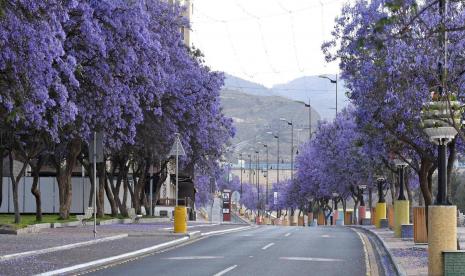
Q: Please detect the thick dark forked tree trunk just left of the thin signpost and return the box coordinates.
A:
[55,139,81,219]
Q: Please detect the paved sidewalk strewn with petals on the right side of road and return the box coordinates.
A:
[361,225,465,276]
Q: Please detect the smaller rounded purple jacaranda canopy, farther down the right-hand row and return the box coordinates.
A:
[296,107,376,221]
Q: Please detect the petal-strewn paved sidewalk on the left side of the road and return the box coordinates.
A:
[0,223,250,275]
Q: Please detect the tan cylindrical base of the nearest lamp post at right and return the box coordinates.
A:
[428,205,457,276]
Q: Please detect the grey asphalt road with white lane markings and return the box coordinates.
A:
[90,226,366,276]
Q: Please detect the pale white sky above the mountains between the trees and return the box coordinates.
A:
[191,0,347,87]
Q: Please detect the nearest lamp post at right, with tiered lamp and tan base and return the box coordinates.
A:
[421,0,462,275]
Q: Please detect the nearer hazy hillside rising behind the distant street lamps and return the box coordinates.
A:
[220,88,320,163]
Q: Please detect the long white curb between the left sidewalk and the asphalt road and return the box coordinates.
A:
[38,226,253,276]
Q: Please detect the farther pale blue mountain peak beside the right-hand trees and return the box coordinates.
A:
[271,75,348,119]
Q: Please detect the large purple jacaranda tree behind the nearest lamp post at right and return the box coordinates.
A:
[323,0,464,209]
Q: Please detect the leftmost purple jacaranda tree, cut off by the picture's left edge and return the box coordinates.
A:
[0,0,78,223]
